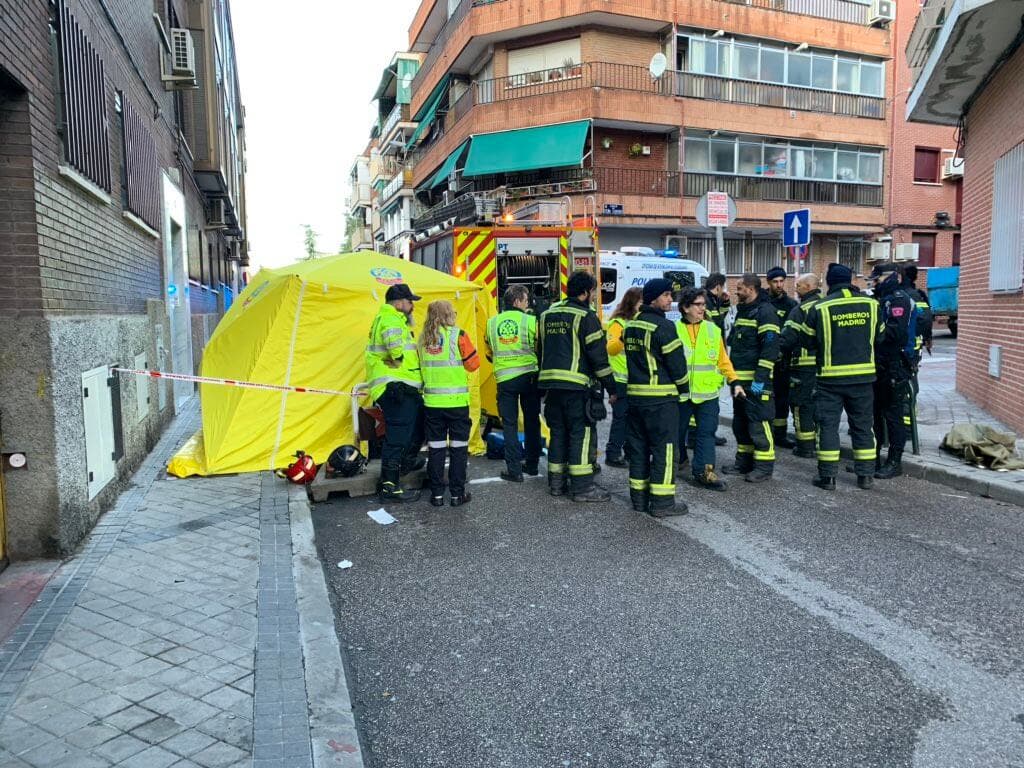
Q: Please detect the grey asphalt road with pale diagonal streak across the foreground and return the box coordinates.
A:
[313,421,1024,768]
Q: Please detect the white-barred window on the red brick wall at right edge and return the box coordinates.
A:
[988,143,1024,291]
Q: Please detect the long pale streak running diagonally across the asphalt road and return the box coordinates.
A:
[660,511,1024,768]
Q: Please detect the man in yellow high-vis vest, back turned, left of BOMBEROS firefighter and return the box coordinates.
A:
[485,286,541,482]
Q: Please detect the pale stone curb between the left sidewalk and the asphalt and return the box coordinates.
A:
[288,484,365,768]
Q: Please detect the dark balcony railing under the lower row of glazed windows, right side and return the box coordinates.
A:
[683,173,883,207]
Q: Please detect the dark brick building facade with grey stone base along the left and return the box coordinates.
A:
[0,0,245,560]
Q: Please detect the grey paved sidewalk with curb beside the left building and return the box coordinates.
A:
[0,402,361,768]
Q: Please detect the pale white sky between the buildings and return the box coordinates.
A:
[231,0,419,272]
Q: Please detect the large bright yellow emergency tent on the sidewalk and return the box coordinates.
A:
[168,251,495,477]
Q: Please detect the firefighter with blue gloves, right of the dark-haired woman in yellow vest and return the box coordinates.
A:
[723,272,780,482]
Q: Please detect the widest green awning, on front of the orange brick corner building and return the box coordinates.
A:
[462,120,590,176]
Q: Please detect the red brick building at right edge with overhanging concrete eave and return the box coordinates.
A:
[906,0,1024,434]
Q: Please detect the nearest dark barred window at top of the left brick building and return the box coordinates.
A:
[53,3,111,191]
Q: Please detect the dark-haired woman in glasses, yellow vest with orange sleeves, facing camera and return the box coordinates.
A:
[676,288,741,490]
